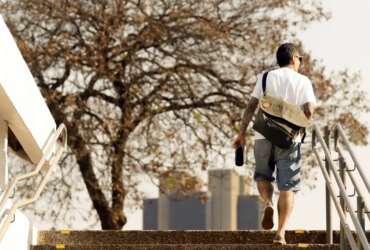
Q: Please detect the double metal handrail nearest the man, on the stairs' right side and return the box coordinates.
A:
[312,125,370,250]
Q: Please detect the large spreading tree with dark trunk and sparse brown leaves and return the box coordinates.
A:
[0,0,368,229]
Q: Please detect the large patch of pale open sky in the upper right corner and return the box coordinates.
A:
[301,0,370,92]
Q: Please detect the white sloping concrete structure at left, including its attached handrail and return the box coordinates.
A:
[0,16,66,250]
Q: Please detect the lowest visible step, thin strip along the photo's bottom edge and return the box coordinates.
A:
[32,244,340,250]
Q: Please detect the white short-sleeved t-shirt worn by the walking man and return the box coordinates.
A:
[252,67,316,141]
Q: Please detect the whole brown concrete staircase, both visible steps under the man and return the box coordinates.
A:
[31,230,370,250]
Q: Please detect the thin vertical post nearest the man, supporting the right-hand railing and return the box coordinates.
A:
[324,126,333,244]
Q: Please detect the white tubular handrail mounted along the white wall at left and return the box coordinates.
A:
[0,124,67,242]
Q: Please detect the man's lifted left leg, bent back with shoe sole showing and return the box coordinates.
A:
[257,181,274,230]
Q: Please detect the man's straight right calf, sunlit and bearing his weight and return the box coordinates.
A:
[276,191,294,242]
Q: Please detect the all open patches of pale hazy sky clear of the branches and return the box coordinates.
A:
[125,0,370,230]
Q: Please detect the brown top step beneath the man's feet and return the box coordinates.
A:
[34,230,370,246]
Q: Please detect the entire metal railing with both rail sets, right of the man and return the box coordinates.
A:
[312,124,370,250]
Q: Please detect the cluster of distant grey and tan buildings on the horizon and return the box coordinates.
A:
[143,169,263,230]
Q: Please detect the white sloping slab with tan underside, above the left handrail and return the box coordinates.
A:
[0,17,55,168]
